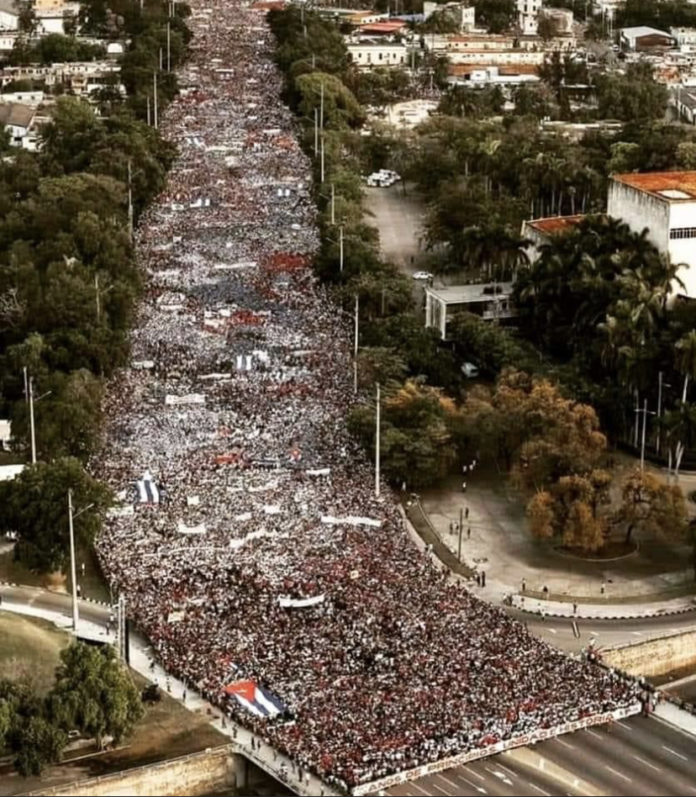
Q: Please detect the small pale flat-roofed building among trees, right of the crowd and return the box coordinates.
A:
[425,282,515,340]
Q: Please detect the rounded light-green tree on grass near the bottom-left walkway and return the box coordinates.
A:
[48,642,143,749]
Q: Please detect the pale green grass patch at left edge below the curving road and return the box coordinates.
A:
[0,611,70,692]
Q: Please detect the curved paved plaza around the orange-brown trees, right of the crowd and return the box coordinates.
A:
[410,469,696,619]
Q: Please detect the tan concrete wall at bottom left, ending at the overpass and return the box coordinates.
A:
[33,745,250,797]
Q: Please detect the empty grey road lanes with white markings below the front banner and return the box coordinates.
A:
[387,717,696,797]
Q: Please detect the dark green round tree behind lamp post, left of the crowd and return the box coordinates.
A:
[0,459,110,572]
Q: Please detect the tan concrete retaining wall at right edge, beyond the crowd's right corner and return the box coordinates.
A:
[602,631,696,677]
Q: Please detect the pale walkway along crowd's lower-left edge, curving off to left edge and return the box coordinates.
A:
[0,588,339,797]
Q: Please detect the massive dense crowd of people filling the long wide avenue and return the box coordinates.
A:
[93,0,638,790]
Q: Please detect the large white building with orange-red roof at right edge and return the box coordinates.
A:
[607,172,696,299]
